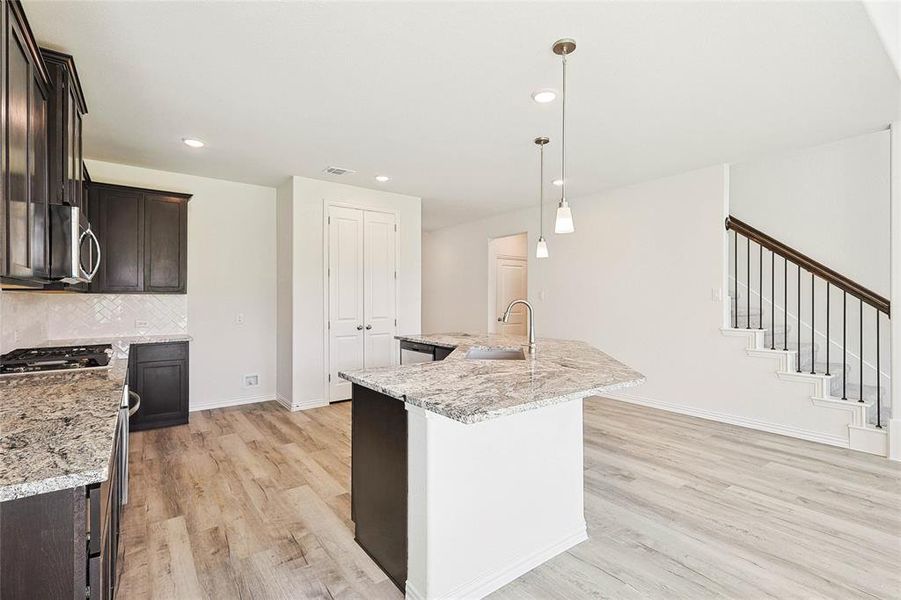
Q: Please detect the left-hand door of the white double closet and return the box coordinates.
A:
[328,206,365,402]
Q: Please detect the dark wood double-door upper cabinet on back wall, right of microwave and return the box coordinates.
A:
[88,183,191,294]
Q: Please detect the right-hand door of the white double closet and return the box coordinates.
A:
[363,211,397,369]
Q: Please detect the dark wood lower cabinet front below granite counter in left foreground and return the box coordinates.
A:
[0,412,128,600]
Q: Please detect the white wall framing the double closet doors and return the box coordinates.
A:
[278,177,422,408]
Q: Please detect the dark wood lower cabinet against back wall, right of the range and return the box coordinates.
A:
[128,342,188,431]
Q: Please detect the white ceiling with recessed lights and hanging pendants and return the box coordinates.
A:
[25,1,899,229]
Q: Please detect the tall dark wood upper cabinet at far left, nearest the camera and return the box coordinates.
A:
[0,0,50,280]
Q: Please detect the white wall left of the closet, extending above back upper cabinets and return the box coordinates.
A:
[85,160,276,410]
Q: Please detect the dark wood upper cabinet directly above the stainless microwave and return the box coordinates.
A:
[41,48,88,209]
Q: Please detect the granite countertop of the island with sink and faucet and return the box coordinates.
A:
[339,333,644,423]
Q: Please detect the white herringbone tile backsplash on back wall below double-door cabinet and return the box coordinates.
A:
[47,294,188,339]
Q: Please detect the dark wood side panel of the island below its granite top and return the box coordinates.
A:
[351,384,407,590]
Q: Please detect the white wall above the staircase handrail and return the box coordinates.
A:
[730,131,891,297]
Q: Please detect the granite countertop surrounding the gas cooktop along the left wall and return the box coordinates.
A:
[0,335,191,502]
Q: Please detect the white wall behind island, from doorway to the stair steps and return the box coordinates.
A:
[423,167,848,440]
